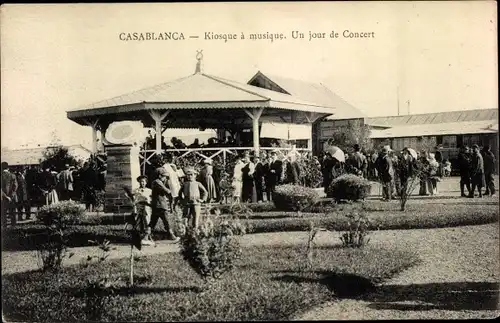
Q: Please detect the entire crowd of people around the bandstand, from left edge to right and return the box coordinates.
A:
[2,142,495,233]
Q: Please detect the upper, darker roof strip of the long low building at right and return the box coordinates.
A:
[365,109,498,127]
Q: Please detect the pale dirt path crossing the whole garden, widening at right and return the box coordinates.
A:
[2,224,500,320]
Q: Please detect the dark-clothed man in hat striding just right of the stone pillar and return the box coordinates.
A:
[149,167,179,241]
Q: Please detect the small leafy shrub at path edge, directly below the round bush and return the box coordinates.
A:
[340,213,370,248]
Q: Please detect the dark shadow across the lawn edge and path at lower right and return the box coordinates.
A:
[273,271,500,311]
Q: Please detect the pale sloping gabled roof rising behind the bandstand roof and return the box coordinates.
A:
[247,71,365,120]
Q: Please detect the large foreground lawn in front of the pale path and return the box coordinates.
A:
[2,245,419,322]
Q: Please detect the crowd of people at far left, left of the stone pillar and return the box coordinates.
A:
[1,161,105,225]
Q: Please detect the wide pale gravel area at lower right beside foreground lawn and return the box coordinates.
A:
[296,224,500,320]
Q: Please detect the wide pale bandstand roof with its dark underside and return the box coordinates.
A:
[67,63,337,128]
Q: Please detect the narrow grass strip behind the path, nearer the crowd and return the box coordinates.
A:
[2,200,499,251]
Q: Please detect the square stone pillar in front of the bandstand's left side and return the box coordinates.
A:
[104,145,140,214]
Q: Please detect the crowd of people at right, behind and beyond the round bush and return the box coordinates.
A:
[322,145,496,201]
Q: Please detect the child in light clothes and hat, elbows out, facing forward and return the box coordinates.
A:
[179,168,208,228]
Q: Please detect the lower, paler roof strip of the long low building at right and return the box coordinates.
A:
[370,119,498,139]
